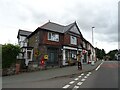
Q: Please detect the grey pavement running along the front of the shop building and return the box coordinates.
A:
[2,60,102,84]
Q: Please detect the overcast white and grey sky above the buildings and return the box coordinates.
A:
[0,0,119,53]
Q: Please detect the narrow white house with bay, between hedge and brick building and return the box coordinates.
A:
[17,29,33,66]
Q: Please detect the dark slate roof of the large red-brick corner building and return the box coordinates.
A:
[39,21,75,33]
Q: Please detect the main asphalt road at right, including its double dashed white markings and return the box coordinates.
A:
[63,61,120,90]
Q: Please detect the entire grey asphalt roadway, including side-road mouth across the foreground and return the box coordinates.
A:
[3,61,119,90]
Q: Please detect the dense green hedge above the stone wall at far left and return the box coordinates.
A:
[2,44,20,68]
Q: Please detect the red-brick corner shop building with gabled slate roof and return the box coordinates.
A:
[27,22,82,66]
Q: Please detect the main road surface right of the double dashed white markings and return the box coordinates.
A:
[80,61,118,88]
